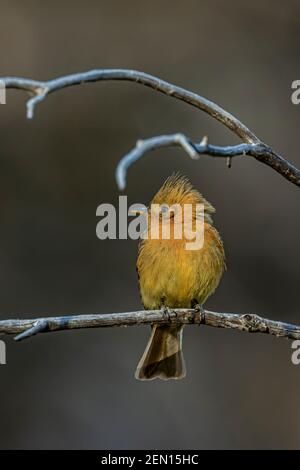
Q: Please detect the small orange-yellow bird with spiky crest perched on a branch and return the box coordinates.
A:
[135,174,225,380]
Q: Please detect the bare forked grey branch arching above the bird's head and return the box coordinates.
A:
[2,69,300,189]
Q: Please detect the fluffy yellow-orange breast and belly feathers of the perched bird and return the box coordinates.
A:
[137,223,225,309]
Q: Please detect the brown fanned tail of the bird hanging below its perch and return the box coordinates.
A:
[135,325,186,380]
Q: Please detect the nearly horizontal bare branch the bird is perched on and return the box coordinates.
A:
[0,309,300,341]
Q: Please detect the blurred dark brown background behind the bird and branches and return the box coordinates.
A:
[0,0,300,449]
